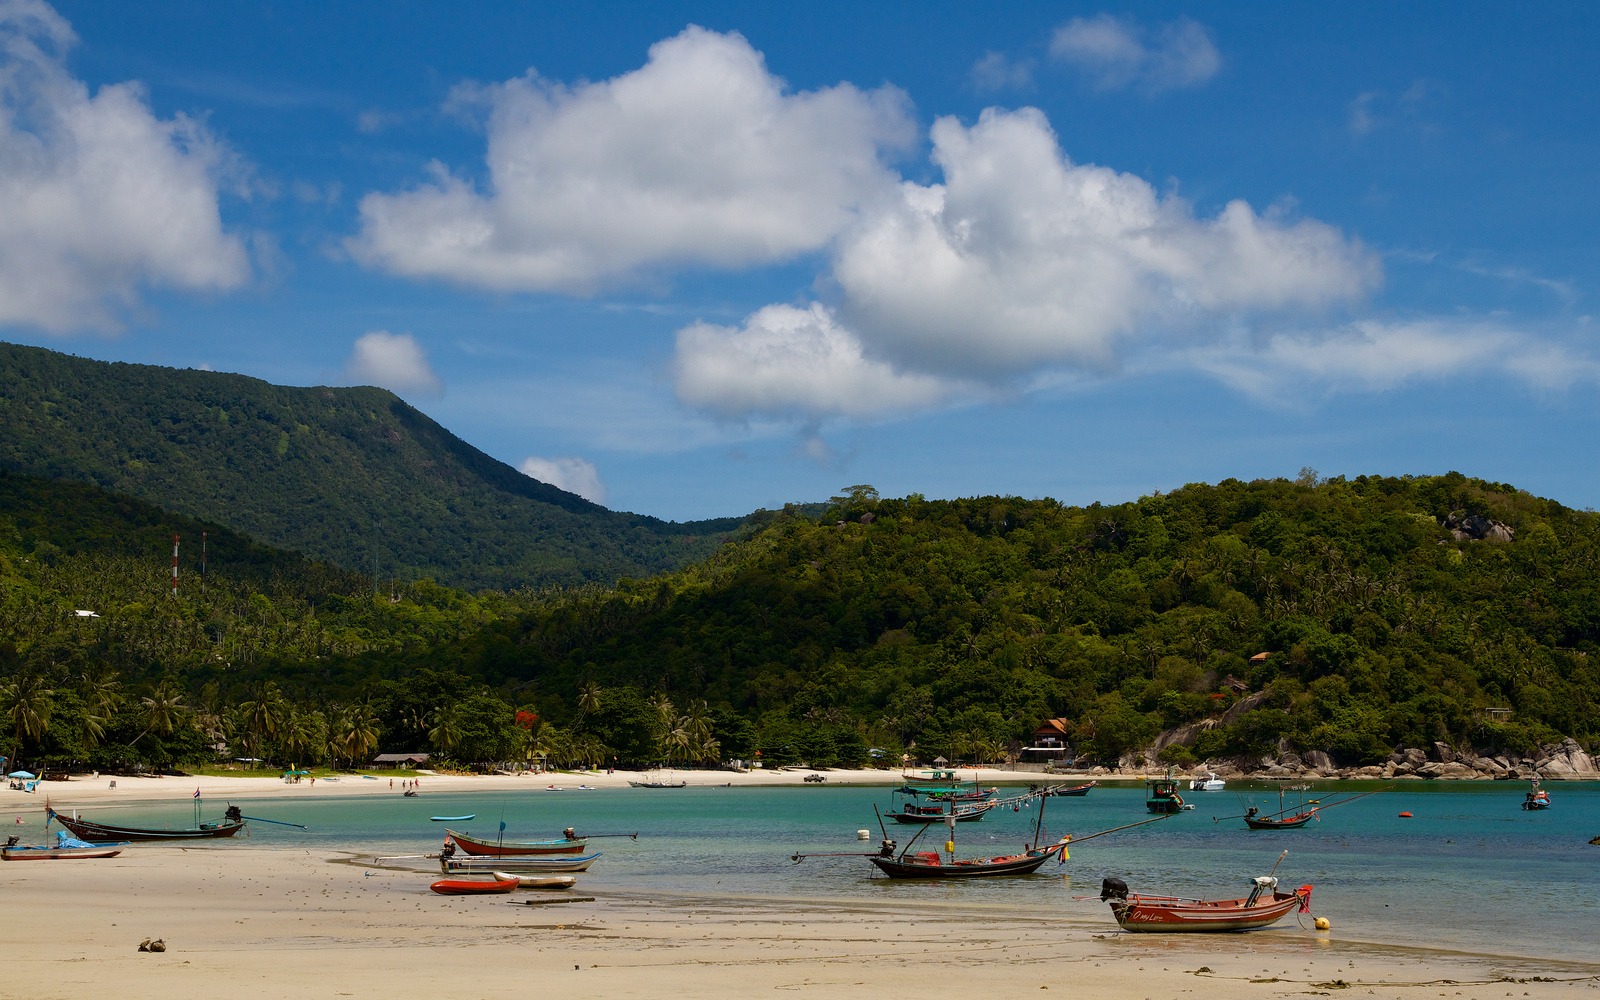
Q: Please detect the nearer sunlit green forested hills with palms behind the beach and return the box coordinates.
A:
[0,474,1600,765]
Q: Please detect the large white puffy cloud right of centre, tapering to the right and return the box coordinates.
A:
[832,109,1381,378]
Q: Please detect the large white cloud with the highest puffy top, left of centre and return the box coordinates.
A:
[349,27,915,293]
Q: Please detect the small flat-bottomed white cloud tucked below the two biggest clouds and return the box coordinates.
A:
[674,297,954,419]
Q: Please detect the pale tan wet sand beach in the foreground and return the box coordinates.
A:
[0,844,1600,1000]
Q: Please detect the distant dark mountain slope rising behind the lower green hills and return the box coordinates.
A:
[0,344,742,589]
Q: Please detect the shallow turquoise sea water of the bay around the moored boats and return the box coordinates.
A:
[40,779,1600,960]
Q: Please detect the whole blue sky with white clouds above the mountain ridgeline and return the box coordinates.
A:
[0,0,1600,518]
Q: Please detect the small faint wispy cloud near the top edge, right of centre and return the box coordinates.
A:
[1050,14,1222,93]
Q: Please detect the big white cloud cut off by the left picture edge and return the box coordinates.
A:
[0,0,250,331]
